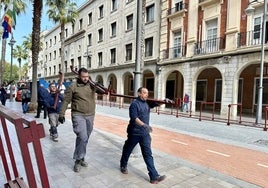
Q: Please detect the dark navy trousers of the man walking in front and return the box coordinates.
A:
[120,134,159,180]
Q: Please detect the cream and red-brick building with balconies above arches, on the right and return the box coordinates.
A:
[158,0,268,115]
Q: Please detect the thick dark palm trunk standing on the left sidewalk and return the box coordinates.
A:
[29,0,43,111]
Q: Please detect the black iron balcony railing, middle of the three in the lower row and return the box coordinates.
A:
[194,37,225,55]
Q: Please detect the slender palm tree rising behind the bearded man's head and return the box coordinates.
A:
[46,0,78,80]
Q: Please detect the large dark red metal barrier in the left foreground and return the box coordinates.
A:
[0,105,50,188]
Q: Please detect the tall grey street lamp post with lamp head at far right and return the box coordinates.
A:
[245,0,267,125]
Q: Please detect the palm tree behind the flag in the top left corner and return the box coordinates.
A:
[0,0,27,84]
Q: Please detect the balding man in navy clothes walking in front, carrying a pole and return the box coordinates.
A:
[120,87,166,184]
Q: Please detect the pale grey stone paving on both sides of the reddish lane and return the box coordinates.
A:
[0,102,268,188]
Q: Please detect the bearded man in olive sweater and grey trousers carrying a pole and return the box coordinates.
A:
[59,68,96,172]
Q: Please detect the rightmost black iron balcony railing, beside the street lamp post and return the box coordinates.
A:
[237,29,267,48]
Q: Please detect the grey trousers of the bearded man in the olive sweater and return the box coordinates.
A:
[72,115,94,160]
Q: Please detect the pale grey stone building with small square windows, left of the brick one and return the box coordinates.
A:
[41,0,161,96]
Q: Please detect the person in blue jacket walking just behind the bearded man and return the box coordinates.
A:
[44,83,63,141]
